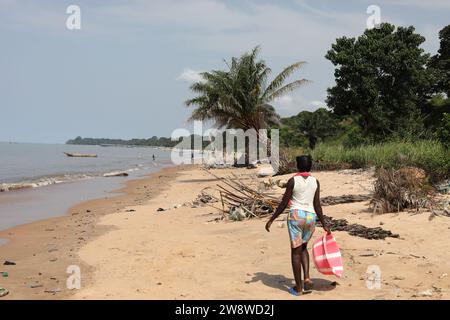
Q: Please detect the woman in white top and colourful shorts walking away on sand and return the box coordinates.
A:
[266,156,330,296]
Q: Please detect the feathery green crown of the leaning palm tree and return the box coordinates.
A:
[186,47,308,132]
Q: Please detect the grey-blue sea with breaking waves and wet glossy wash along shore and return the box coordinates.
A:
[0,142,172,234]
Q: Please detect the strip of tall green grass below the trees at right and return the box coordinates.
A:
[288,140,450,181]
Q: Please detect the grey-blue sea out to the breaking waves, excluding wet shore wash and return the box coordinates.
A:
[0,142,170,185]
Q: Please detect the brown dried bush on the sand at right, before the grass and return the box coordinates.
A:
[371,167,432,213]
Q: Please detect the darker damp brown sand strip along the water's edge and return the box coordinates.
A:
[0,166,186,299]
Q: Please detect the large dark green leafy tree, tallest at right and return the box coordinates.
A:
[325,23,430,139]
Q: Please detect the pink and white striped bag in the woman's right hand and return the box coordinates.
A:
[313,234,344,278]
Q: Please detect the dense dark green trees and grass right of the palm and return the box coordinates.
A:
[270,24,450,181]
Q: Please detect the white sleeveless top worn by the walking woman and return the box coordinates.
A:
[290,176,317,213]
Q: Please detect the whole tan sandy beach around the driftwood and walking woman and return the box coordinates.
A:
[0,166,450,299]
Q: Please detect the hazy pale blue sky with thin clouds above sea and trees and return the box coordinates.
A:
[0,0,450,143]
